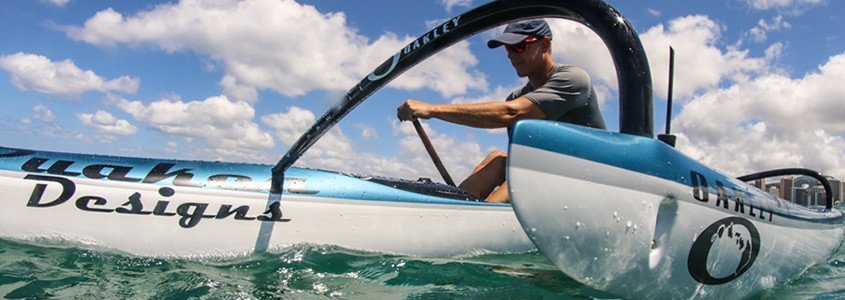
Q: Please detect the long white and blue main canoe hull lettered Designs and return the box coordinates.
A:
[0,148,535,257]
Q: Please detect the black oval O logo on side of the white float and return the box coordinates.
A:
[687,217,760,285]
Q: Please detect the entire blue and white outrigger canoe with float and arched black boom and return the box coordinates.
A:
[0,0,845,298]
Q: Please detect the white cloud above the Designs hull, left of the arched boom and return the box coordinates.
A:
[111,96,275,161]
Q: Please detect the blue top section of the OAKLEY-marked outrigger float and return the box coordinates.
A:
[511,120,843,224]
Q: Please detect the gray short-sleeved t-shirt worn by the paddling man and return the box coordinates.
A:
[506,64,606,129]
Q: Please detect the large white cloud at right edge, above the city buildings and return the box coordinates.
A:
[673,53,845,178]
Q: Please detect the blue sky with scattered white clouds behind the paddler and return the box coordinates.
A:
[0,0,845,181]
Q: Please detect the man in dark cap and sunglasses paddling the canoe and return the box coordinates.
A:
[396,19,605,202]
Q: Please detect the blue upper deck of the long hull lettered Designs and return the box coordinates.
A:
[0,147,510,207]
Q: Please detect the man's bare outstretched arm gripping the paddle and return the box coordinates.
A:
[396,97,546,128]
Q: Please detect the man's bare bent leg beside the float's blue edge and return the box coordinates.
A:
[458,151,508,199]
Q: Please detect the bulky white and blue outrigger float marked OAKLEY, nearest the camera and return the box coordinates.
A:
[508,122,843,298]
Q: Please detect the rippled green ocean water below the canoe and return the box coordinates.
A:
[0,232,845,299]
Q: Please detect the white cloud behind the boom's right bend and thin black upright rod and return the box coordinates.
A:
[549,15,772,103]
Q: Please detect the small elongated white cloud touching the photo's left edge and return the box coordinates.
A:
[0,52,140,97]
